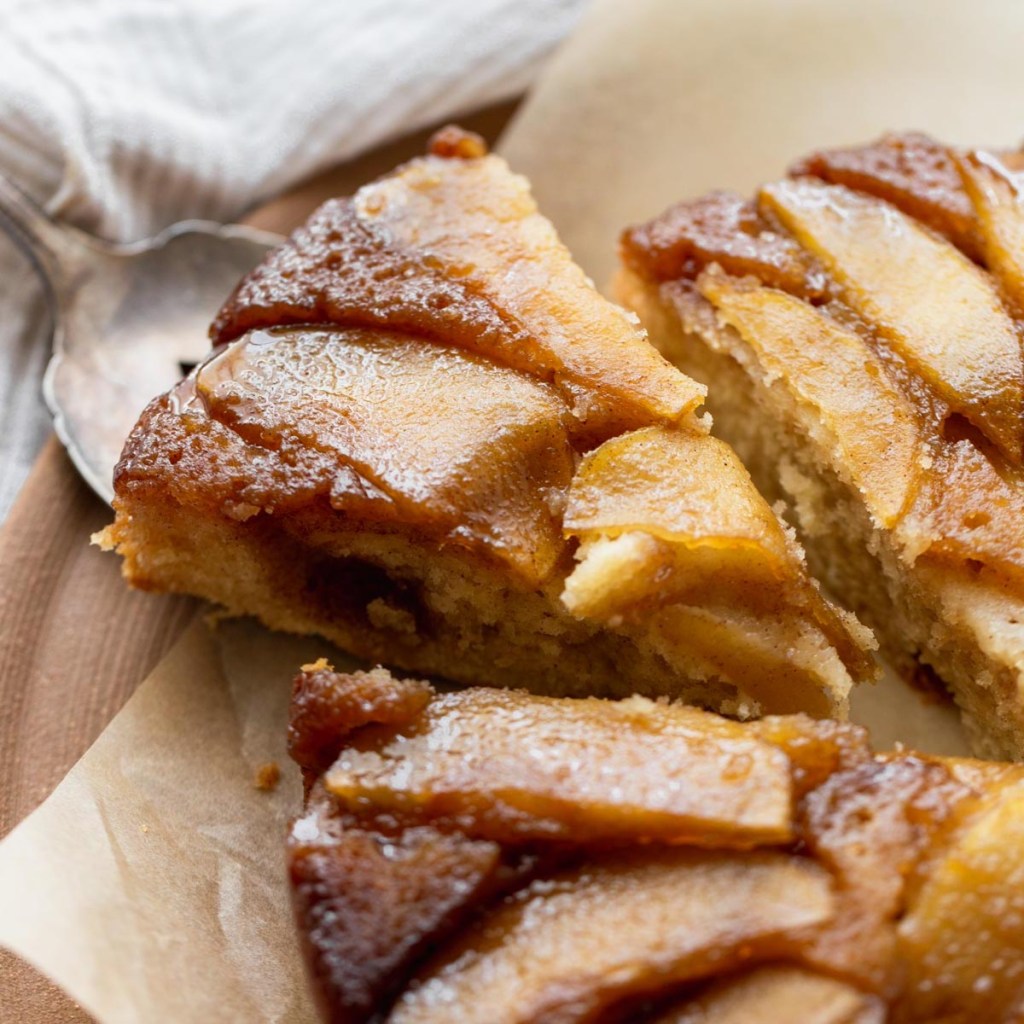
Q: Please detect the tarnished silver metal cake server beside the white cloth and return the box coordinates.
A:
[0,175,282,502]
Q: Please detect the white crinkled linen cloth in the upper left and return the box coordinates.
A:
[0,0,586,519]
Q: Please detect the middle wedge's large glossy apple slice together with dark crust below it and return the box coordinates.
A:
[115,329,577,584]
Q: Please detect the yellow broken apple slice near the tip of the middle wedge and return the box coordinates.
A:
[562,427,874,688]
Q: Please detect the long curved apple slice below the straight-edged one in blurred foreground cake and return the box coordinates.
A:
[390,850,833,1024]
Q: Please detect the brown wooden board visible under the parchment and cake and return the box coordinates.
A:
[0,103,515,1024]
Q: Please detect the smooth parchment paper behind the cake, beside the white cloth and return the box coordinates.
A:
[502,0,1024,285]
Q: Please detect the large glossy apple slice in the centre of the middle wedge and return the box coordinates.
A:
[196,329,573,582]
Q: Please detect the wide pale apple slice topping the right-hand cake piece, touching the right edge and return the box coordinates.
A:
[761,181,1022,463]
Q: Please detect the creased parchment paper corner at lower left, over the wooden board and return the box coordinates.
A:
[0,617,364,1024]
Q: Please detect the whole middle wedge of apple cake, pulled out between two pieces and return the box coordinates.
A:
[101,130,874,717]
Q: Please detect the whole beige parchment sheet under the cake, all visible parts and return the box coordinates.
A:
[0,0,1024,1024]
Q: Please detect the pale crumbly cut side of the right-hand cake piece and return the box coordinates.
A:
[615,269,1024,760]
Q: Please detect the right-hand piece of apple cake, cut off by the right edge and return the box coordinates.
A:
[617,135,1024,759]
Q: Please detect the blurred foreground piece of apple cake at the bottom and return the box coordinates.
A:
[289,666,1024,1024]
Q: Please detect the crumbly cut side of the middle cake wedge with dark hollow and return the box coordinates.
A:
[103,468,844,718]
